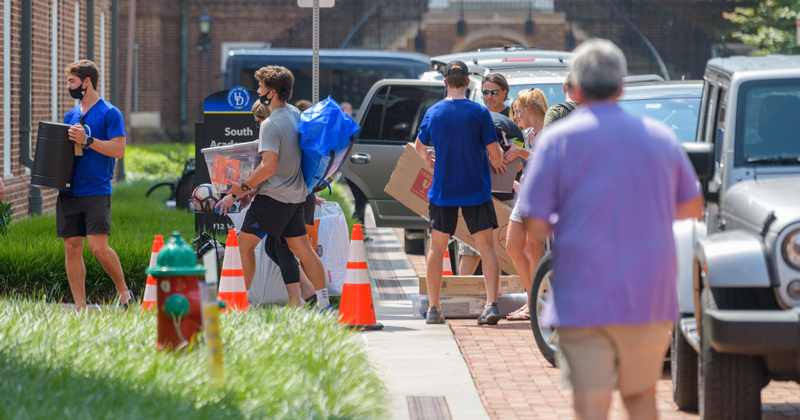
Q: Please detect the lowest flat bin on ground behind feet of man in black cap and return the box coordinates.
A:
[410,293,528,319]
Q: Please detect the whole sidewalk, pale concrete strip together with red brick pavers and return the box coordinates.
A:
[361,225,800,420]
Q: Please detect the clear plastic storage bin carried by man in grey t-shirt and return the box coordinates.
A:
[201,142,261,193]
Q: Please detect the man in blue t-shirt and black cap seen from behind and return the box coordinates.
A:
[415,61,505,325]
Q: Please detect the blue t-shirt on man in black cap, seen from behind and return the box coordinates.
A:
[419,99,497,207]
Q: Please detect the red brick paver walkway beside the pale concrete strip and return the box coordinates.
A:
[401,246,800,420]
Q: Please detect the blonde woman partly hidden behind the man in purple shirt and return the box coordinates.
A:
[503,89,547,320]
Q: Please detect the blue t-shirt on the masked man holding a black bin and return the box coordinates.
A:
[62,98,125,197]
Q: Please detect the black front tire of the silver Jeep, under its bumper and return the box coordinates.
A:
[698,288,765,420]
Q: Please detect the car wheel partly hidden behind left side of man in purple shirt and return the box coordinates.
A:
[528,253,558,366]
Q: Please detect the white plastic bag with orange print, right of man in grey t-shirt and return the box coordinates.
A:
[309,201,350,296]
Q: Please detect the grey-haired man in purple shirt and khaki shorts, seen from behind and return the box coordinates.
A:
[520,39,703,419]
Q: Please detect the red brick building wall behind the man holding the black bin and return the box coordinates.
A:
[0,0,112,218]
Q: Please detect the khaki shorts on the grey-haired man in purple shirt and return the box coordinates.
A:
[556,322,673,396]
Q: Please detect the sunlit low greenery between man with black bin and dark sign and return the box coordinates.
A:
[125,143,195,180]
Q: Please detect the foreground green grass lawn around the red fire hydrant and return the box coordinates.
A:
[0,300,387,420]
